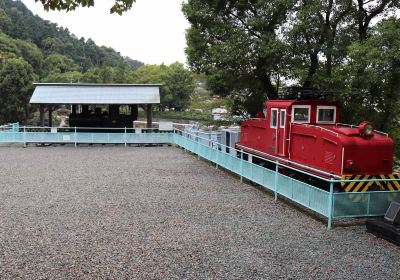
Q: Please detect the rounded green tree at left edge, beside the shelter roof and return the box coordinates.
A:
[0,58,35,123]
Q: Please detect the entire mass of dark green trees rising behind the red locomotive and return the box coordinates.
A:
[183,0,399,124]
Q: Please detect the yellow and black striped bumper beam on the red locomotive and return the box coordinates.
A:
[340,174,400,192]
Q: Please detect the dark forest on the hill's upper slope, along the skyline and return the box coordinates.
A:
[0,0,143,71]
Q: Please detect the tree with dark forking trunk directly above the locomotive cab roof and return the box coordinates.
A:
[284,0,354,88]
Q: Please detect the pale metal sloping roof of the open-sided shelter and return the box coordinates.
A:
[29,83,161,105]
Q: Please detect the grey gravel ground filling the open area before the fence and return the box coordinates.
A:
[0,146,400,279]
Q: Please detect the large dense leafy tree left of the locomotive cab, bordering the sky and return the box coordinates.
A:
[183,0,295,115]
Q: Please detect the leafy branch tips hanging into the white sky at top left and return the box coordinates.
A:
[35,0,135,14]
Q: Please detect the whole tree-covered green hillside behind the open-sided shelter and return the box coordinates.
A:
[0,0,195,123]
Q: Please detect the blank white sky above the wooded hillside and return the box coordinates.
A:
[22,0,189,64]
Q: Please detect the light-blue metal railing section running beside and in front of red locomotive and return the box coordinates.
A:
[174,130,400,229]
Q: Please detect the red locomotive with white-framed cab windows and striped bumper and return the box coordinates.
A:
[236,88,400,192]
